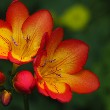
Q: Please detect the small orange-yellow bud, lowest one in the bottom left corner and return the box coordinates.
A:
[1,90,12,106]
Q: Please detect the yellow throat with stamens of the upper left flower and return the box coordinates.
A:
[11,35,31,60]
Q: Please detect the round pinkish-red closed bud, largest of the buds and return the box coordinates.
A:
[13,70,35,94]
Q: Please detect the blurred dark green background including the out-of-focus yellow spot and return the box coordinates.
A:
[0,0,110,110]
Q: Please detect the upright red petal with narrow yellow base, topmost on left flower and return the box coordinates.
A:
[6,1,29,44]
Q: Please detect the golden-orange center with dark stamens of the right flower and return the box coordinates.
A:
[40,59,62,83]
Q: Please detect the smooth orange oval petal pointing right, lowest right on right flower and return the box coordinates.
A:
[66,70,100,93]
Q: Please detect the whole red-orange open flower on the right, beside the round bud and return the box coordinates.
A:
[34,28,99,102]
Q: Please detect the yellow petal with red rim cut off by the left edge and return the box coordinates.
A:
[0,20,12,59]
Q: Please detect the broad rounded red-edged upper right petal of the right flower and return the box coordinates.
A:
[53,39,88,74]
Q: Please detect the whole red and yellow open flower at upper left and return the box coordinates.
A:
[0,0,53,64]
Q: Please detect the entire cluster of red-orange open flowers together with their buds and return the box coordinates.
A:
[0,0,100,105]
